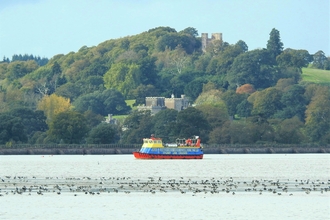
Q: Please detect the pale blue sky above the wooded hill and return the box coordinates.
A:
[0,0,330,60]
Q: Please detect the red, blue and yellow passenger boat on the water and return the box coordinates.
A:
[133,135,203,159]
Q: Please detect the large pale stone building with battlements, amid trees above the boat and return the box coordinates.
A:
[137,94,189,115]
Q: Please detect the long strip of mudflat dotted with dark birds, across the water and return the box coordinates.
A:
[0,176,330,196]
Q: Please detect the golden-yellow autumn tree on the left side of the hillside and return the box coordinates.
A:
[38,94,71,123]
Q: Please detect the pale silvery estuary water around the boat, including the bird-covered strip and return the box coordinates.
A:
[0,154,330,219]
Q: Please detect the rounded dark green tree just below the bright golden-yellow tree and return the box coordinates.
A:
[48,111,88,144]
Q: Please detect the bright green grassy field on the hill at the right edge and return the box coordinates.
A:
[302,68,330,86]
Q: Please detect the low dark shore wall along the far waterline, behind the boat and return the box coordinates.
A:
[0,147,330,155]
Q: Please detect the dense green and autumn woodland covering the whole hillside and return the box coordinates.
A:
[0,27,330,147]
